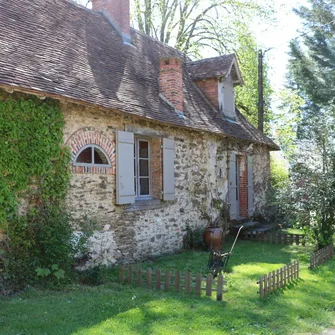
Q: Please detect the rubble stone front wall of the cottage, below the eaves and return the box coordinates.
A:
[62,104,270,264]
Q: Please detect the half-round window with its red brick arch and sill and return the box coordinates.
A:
[66,127,115,174]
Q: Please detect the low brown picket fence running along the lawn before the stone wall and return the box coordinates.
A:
[119,265,226,301]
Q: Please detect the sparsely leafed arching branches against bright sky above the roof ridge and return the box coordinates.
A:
[133,0,271,55]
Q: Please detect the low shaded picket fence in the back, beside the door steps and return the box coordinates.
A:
[242,231,305,245]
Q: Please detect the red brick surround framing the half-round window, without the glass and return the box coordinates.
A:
[66,127,115,174]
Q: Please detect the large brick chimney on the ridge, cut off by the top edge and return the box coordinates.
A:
[92,0,131,43]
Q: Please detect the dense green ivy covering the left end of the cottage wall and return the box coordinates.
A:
[0,91,92,291]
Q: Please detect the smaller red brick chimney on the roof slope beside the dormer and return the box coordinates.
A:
[159,57,184,112]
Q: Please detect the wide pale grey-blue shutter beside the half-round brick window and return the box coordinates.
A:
[116,131,135,205]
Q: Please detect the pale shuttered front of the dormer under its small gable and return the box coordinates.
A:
[218,75,236,120]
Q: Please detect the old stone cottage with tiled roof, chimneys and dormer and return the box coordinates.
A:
[0,0,279,264]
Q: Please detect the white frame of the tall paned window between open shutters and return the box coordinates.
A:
[134,137,152,200]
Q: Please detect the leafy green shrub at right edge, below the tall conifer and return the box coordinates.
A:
[290,147,335,249]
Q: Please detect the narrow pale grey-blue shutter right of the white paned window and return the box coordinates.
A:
[163,138,175,200]
